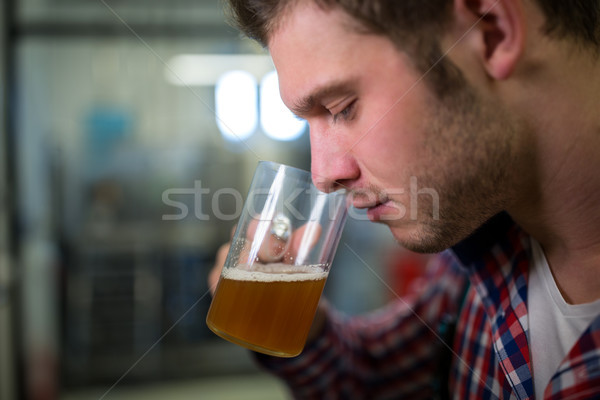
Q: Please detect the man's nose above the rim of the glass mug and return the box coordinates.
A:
[310,126,360,192]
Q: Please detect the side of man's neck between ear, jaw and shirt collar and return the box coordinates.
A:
[509,43,600,304]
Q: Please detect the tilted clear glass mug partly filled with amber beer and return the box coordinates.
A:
[206,162,348,357]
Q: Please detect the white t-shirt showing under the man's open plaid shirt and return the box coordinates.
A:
[527,239,600,398]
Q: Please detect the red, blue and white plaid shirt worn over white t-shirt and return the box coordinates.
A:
[257,214,600,400]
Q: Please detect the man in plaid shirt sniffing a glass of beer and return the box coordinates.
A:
[211,0,600,399]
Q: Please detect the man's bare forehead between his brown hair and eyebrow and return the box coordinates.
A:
[268,2,396,106]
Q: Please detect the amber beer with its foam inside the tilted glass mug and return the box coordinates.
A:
[206,268,327,357]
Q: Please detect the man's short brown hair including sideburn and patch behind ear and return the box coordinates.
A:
[228,0,600,97]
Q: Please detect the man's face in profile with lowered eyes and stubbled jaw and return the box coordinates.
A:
[269,2,514,251]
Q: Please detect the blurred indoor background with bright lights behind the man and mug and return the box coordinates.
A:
[0,0,432,400]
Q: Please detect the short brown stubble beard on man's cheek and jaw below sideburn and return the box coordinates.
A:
[390,84,518,253]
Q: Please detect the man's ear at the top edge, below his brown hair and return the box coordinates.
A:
[454,0,526,80]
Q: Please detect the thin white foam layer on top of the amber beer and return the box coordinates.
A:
[223,264,328,282]
